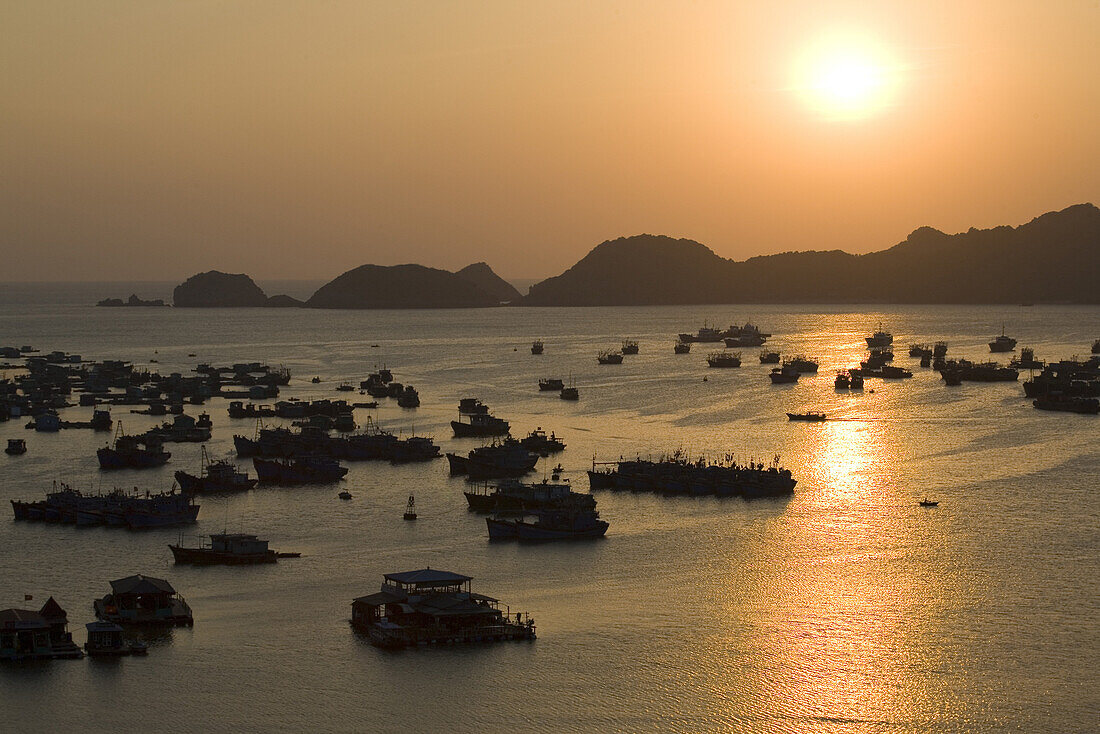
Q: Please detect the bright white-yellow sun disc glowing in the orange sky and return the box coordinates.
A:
[794,33,899,120]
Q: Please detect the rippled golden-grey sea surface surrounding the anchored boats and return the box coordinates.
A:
[0,284,1100,734]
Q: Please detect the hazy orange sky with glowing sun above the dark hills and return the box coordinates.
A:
[0,0,1100,281]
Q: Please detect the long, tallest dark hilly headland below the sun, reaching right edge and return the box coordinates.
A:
[519,204,1100,306]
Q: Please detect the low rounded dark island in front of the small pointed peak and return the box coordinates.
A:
[306,265,499,308]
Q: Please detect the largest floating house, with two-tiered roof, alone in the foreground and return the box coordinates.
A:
[351,568,535,647]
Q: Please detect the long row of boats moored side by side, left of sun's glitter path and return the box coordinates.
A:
[589,452,796,499]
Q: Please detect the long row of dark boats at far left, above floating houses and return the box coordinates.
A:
[11,484,199,529]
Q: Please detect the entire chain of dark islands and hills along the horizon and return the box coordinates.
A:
[116,204,1100,309]
